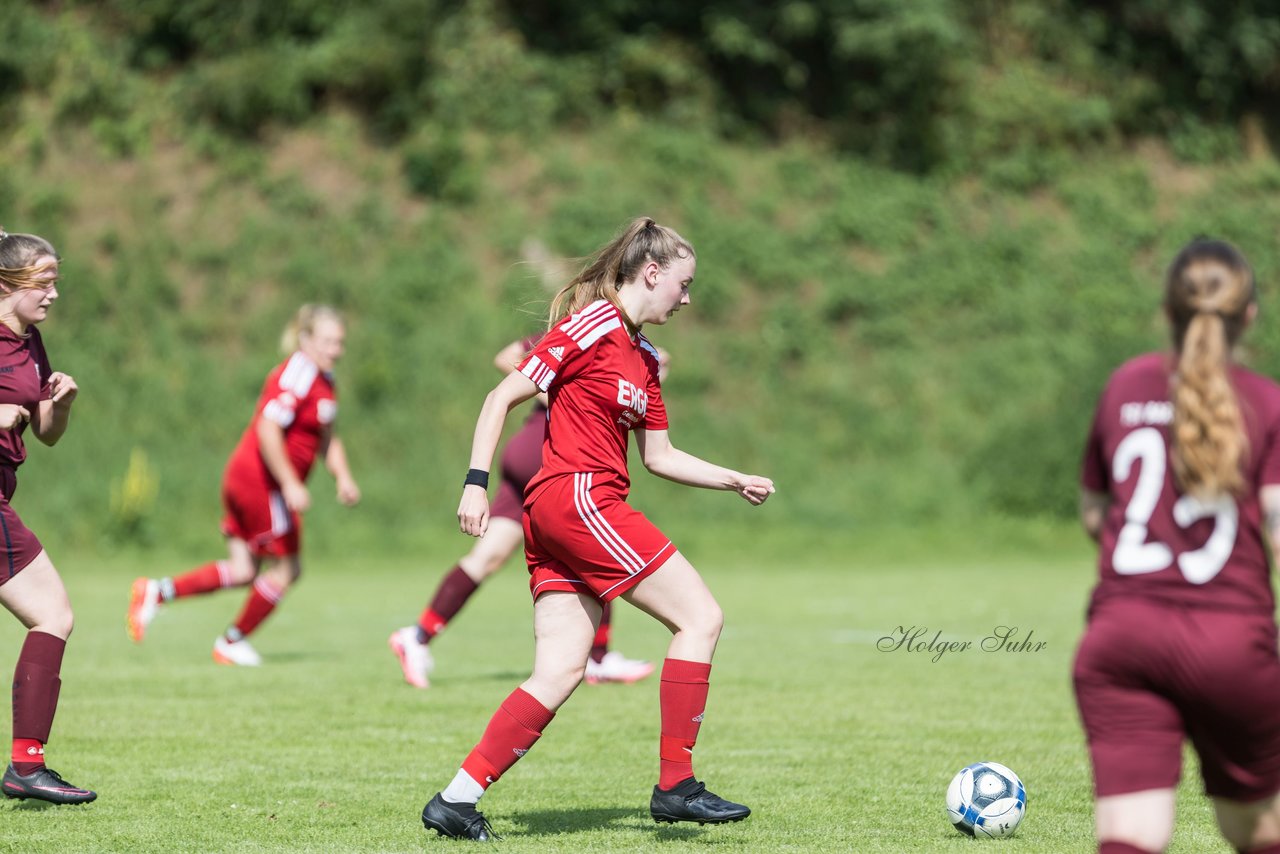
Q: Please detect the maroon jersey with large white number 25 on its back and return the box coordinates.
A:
[1082,353,1280,615]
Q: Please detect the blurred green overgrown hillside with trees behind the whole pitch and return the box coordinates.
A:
[0,0,1280,555]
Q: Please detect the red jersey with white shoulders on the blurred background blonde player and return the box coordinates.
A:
[227,352,338,489]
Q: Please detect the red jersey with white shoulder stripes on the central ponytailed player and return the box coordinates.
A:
[518,300,667,504]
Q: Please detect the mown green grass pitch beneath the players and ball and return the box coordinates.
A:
[0,528,1244,854]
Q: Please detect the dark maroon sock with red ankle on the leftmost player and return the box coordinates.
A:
[12,631,67,775]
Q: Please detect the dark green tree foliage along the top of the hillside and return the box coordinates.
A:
[0,0,1264,170]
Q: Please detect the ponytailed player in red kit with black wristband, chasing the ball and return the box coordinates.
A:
[422,219,773,840]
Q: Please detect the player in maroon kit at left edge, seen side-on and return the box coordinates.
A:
[0,229,97,804]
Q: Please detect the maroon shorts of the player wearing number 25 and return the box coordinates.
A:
[1073,598,1280,802]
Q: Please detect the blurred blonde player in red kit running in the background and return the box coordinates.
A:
[127,305,360,667]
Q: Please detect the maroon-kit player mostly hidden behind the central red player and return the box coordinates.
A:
[388,335,668,688]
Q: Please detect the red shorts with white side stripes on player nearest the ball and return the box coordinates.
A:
[524,474,676,602]
